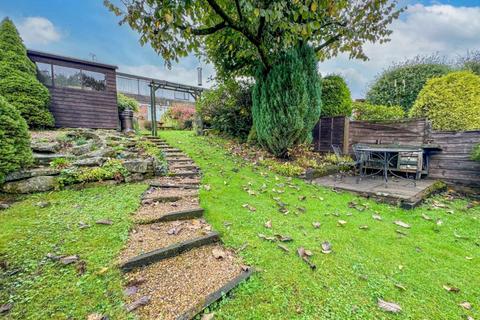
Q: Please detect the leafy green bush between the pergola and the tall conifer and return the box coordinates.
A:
[196,79,252,141]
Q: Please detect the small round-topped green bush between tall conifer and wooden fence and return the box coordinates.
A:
[322,75,352,117]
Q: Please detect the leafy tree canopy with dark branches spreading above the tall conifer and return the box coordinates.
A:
[104,0,403,75]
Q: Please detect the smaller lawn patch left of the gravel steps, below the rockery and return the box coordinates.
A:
[0,184,147,319]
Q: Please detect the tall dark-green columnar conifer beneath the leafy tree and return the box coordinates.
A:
[252,46,321,157]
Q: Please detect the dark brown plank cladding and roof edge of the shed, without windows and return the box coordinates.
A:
[28,51,119,129]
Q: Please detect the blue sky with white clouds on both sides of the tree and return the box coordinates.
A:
[0,0,480,98]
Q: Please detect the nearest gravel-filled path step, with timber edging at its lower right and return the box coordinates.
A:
[126,244,253,320]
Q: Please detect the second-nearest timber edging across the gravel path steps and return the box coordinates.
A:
[120,231,220,272]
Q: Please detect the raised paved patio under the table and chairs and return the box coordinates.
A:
[312,175,443,209]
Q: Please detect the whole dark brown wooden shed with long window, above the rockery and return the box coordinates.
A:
[28,50,119,129]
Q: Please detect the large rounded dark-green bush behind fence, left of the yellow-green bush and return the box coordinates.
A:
[366,57,451,112]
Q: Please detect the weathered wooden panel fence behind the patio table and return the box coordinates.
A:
[313,117,480,187]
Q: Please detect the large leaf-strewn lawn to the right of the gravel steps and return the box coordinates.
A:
[160,131,480,319]
